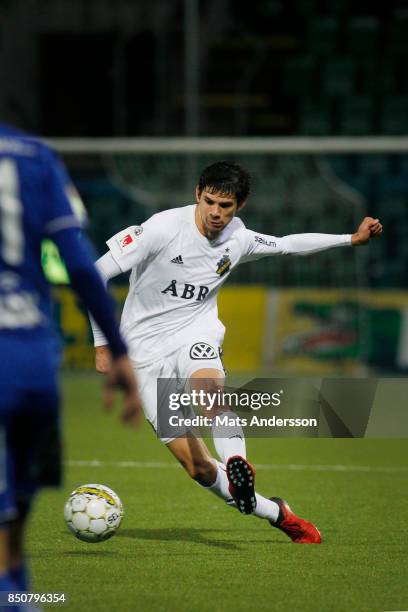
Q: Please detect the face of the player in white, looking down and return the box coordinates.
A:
[196,188,243,239]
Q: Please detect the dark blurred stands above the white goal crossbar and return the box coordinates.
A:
[0,0,408,136]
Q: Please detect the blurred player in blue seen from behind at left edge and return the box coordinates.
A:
[0,124,140,591]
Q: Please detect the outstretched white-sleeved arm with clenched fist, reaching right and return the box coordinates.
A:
[241,217,382,262]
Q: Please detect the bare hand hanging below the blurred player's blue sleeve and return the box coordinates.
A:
[104,355,142,423]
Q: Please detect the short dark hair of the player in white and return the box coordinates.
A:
[198,161,251,205]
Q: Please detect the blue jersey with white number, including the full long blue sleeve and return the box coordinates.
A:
[0,125,126,356]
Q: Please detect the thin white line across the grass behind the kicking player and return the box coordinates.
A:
[66,459,408,474]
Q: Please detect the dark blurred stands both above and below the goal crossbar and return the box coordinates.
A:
[0,0,408,288]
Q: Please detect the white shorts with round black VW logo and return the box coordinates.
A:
[135,339,225,444]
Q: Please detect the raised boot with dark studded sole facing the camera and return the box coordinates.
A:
[227,455,256,514]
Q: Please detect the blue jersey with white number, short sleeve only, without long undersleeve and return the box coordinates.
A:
[0,125,80,334]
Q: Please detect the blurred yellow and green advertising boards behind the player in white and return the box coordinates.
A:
[54,285,408,376]
